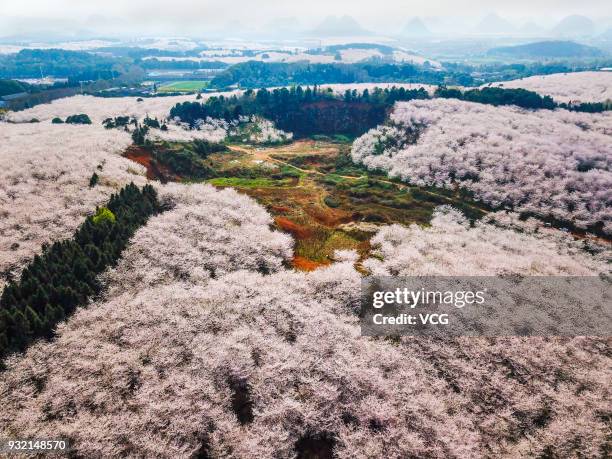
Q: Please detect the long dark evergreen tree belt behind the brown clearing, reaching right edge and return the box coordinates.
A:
[170,86,610,138]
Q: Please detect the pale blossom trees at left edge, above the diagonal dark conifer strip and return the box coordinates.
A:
[0,122,146,290]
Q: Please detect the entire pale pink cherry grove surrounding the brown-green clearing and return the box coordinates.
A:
[0,85,612,459]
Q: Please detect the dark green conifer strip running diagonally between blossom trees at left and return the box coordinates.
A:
[0,183,161,358]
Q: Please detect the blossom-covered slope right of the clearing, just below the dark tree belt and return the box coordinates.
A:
[352,99,612,234]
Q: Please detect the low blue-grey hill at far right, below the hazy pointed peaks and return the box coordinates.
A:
[487,41,605,59]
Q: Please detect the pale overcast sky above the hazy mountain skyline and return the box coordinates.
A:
[0,0,612,36]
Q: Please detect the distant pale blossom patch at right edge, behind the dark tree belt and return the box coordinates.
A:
[493,72,612,103]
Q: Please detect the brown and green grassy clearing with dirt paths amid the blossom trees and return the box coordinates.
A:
[128,140,486,270]
